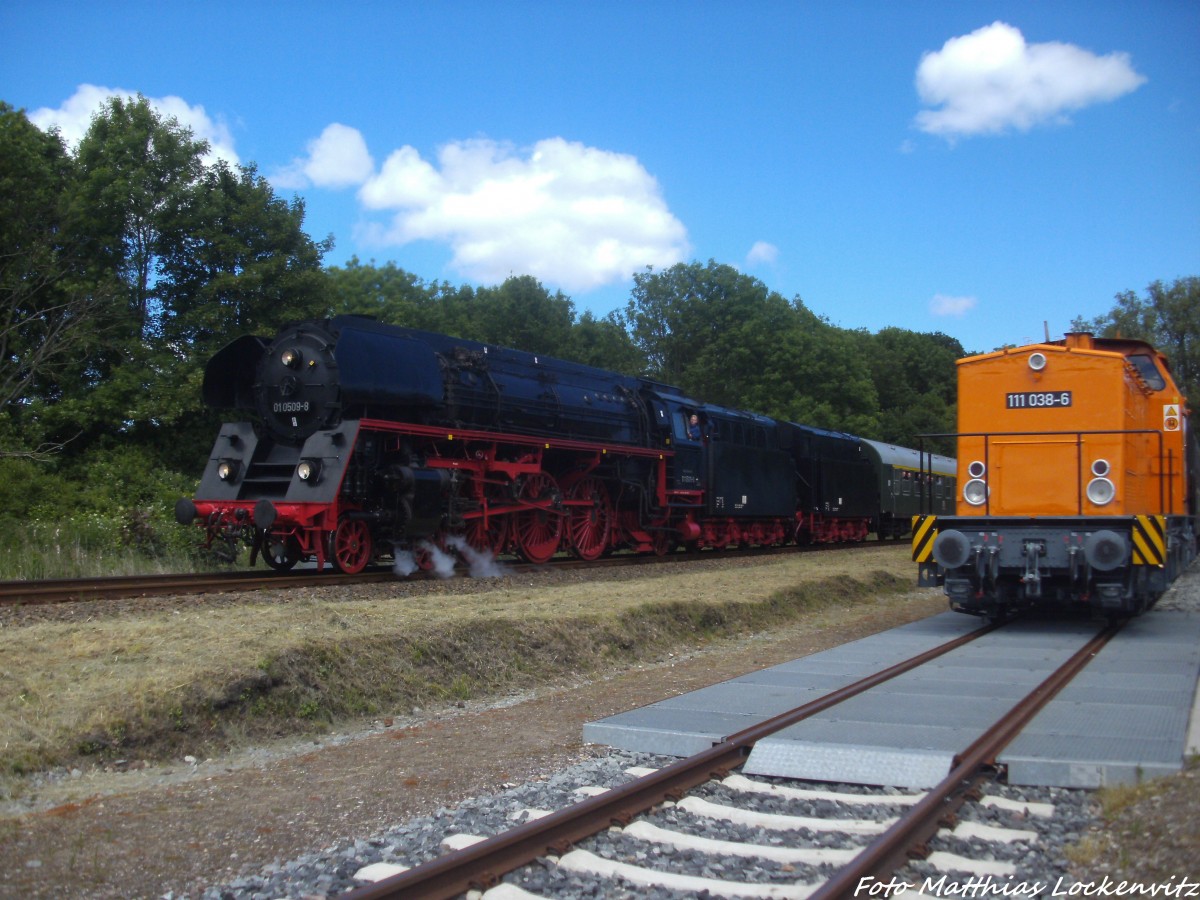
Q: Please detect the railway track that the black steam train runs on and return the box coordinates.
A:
[0,541,893,606]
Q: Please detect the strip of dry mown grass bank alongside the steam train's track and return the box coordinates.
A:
[0,548,913,773]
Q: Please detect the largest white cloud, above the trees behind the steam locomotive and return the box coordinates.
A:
[359,138,688,290]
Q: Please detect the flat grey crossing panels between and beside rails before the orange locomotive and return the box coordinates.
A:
[583,611,1200,788]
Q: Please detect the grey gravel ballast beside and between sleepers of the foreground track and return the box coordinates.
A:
[194,571,1200,900]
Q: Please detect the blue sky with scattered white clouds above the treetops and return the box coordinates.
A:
[0,0,1200,350]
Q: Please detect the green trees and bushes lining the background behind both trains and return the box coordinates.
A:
[9,96,1185,570]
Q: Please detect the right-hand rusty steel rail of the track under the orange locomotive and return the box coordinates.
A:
[809,624,1121,900]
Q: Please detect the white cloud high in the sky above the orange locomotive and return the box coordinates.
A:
[917,22,1146,138]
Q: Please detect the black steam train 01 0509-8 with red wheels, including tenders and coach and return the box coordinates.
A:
[175,316,956,572]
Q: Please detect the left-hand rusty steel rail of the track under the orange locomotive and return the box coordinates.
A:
[343,624,998,900]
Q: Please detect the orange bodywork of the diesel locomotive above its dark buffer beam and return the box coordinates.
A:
[958,335,1187,517]
